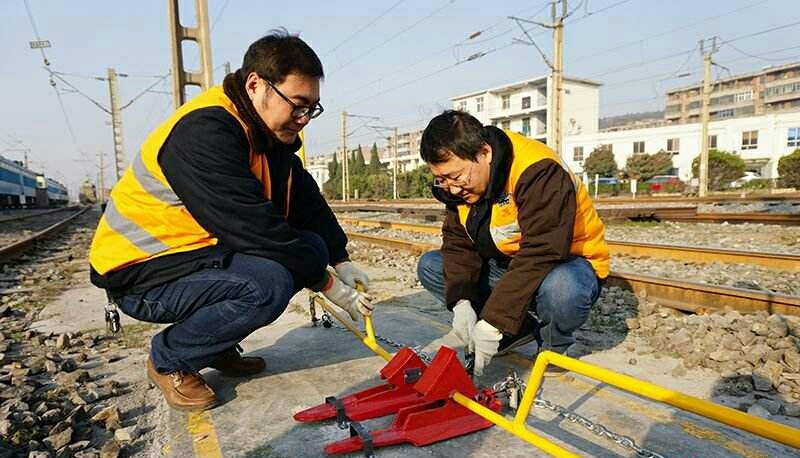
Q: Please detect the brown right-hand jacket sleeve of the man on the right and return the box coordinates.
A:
[481,160,576,334]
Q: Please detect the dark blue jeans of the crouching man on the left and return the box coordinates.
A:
[117,232,328,373]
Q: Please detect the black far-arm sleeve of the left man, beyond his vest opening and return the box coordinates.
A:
[289,156,348,265]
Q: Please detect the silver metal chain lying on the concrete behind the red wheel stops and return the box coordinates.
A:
[311,300,666,458]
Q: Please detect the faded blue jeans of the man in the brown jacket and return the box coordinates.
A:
[417,250,601,353]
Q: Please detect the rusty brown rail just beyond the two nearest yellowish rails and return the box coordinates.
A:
[331,204,800,226]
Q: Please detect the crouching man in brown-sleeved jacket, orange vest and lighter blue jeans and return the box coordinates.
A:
[417,111,609,375]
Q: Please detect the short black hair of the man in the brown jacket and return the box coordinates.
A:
[420,110,486,164]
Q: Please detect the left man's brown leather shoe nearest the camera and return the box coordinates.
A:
[147,358,217,410]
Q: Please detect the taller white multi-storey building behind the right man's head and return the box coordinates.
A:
[450,76,600,145]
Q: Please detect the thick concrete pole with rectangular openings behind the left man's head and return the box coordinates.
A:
[167,0,214,108]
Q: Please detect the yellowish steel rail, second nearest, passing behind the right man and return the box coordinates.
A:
[339,218,800,272]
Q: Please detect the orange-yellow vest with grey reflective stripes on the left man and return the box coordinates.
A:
[89,86,291,275]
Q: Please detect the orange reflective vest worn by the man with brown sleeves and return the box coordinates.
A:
[458,130,609,278]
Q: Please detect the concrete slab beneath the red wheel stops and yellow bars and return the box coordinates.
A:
[153,285,796,458]
